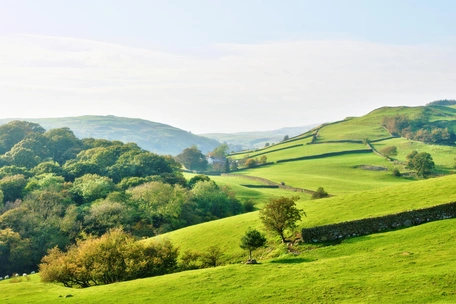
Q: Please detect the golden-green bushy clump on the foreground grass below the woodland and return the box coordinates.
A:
[39,229,178,288]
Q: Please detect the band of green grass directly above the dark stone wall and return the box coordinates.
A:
[152,175,456,262]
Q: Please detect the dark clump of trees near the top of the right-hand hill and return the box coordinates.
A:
[382,112,456,145]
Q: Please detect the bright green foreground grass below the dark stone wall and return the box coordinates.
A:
[0,219,456,303]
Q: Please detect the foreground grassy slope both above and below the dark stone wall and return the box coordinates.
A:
[0,176,456,303]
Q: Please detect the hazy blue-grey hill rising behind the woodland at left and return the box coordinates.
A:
[0,115,220,155]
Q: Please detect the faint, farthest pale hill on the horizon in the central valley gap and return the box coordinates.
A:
[201,124,318,151]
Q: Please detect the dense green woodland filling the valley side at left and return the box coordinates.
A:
[0,121,244,275]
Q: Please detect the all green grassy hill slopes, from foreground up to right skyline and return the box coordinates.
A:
[0,104,456,303]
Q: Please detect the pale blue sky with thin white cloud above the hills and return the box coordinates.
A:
[0,0,456,134]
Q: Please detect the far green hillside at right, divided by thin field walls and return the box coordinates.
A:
[225,106,456,195]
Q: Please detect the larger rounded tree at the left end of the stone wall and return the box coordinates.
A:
[260,196,306,243]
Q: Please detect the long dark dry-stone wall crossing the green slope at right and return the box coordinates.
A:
[302,202,456,243]
